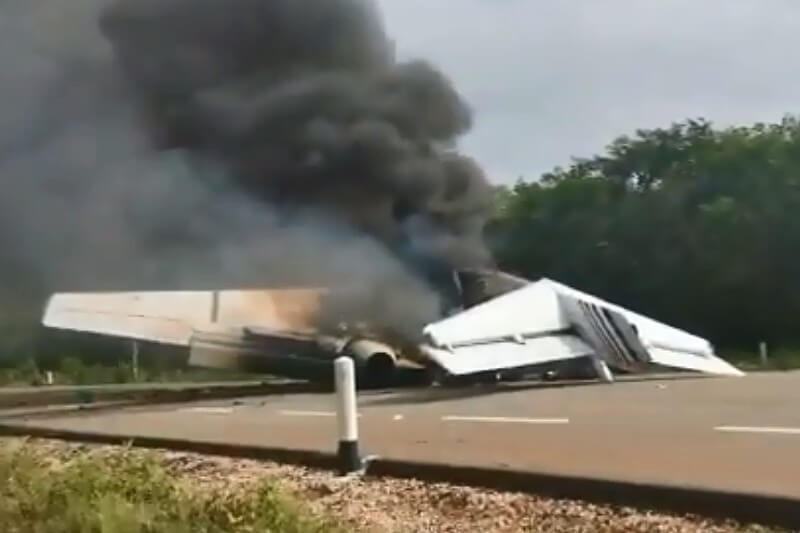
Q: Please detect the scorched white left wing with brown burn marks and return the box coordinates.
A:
[42,288,340,377]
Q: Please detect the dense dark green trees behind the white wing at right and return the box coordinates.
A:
[489,117,800,349]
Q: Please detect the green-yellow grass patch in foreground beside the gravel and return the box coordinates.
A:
[0,438,344,533]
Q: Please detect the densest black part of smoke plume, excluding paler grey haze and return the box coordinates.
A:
[101,0,490,266]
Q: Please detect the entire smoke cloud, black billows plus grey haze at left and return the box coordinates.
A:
[0,0,491,340]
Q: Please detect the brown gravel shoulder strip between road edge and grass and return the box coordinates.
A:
[0,438,788,533]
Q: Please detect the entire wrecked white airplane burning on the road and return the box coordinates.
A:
[42,272,743,383]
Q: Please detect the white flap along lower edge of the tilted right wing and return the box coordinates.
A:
[425,335,593,376]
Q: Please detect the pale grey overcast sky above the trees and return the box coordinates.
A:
[378,0,800,183]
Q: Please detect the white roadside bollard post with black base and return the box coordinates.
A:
[334,357,363,474]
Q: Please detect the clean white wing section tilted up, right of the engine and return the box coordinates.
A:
[424,279,743,376]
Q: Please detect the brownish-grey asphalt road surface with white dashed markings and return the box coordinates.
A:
[3,373,800,498]
